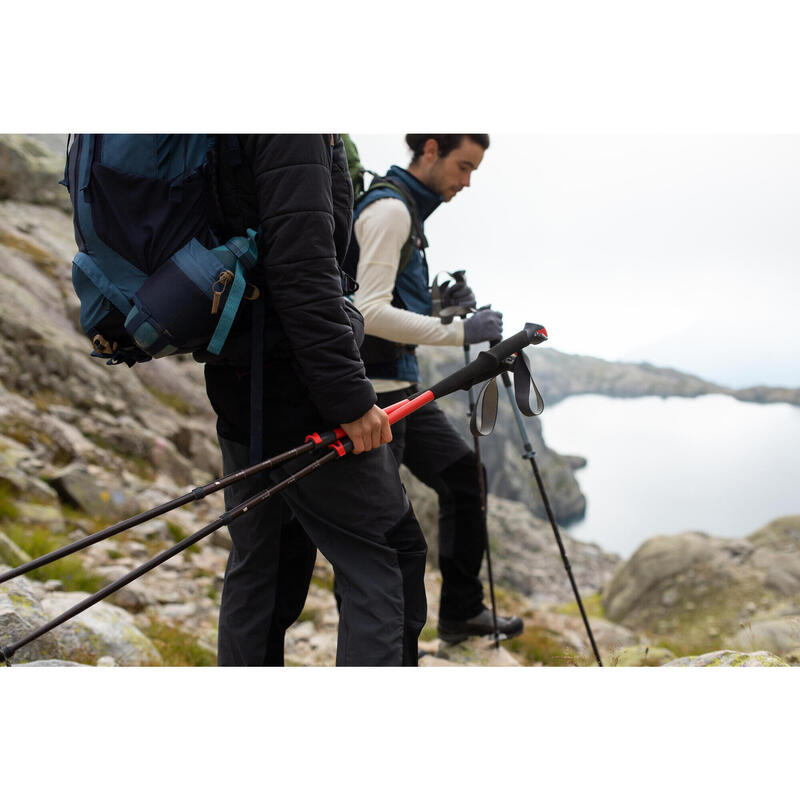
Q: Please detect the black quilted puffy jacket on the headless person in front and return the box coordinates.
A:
[196,134,376,423]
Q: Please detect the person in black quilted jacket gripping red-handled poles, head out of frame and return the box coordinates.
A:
[196,134,426,666]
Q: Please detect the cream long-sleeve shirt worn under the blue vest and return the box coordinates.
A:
[353,197,464,392]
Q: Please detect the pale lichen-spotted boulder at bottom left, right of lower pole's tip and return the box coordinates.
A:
[42,592,161,666]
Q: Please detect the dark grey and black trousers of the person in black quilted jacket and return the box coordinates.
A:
[218,431,427,666]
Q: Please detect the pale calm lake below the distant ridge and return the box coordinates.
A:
[541,395,800,558]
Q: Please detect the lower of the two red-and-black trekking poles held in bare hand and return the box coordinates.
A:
[0,324,547,666]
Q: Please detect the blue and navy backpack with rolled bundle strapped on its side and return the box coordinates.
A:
[63,134,258,366]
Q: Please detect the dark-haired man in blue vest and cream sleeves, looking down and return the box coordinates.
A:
[345,134,523,643]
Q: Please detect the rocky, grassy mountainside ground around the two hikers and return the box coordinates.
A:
[0,137,800,666]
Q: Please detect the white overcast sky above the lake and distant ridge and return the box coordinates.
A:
[352,131,800,387]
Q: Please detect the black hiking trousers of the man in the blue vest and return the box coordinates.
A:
[378,386,485,620]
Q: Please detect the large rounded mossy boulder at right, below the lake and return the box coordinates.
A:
[603,517,800,652]
